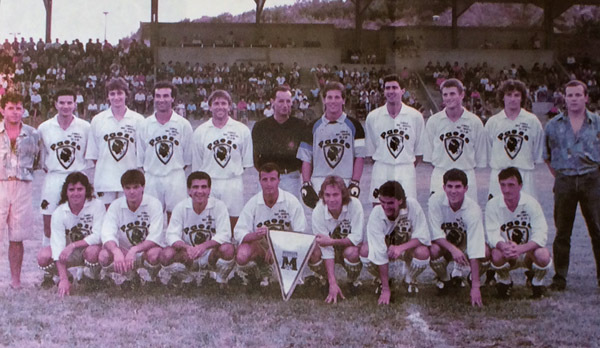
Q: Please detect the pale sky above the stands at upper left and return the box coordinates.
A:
[0,0,295,43]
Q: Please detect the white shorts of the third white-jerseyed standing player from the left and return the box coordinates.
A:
[144,169,188,211]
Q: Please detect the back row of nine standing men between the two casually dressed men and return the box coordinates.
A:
[2,75,584,304]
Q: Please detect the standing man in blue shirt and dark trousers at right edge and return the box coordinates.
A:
[544,80,600,291]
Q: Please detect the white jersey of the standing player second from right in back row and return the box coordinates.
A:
[423,109,487,170]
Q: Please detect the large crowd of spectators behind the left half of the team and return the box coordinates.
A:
[0,38,310,123]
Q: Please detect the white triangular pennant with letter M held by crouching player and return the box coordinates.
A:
[267,230,315,301]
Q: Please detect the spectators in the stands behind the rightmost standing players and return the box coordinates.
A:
[423,57,600,122]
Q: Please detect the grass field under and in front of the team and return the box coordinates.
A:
[0,120,600,347]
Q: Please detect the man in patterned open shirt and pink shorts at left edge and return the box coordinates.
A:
[0,93,41,289]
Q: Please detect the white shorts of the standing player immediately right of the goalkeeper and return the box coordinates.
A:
[369,161,417,203]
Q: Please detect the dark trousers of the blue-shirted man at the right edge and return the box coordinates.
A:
[552,171,600,281]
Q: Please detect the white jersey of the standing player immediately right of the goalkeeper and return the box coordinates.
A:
[365,103,425,164]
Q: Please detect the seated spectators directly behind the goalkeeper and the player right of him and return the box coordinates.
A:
[310,64,423,119]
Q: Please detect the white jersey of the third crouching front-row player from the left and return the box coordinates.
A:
[166,197,231,246]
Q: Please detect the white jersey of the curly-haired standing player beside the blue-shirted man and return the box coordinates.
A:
[485,109,544,170]
